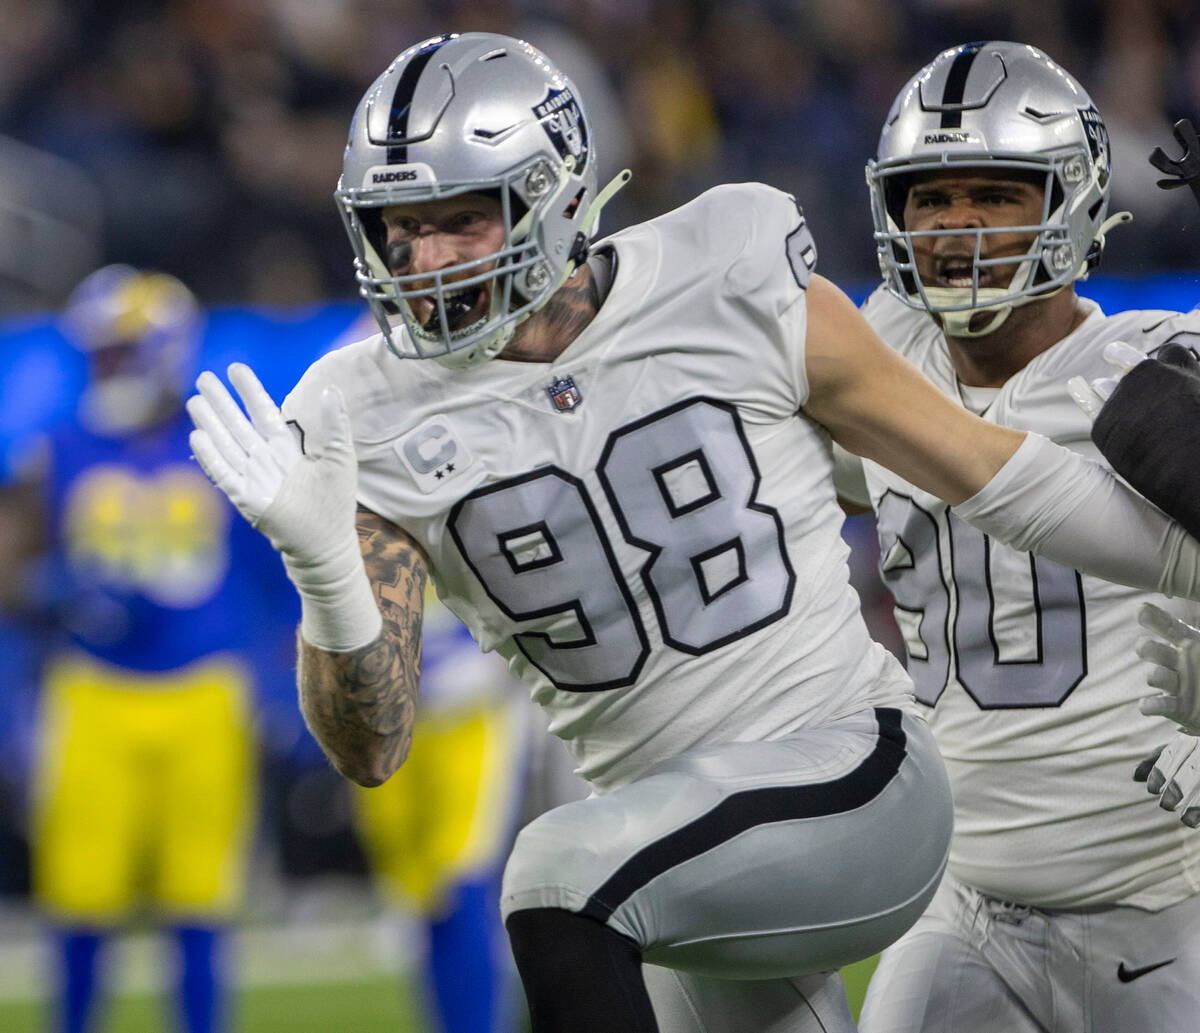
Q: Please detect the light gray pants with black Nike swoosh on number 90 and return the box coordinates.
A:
[860,875,1200,1033]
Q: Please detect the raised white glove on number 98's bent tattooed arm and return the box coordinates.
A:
[187,362,380,651]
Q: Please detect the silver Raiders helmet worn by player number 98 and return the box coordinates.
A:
[335,32,629,366]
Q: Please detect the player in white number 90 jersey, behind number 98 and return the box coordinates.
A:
[839,42,1200,1033]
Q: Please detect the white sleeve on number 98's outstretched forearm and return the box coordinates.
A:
[954,433,1200,599]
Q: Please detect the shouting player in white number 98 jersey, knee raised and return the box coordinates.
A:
[180,34,1200,1033]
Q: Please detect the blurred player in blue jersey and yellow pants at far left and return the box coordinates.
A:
[11,265,274,1033]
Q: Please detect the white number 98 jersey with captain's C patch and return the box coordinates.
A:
[283,185,912,789]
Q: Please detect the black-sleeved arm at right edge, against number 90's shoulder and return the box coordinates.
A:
[1092,345,1200,537]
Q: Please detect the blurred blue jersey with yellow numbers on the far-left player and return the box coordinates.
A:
[49,412,286,672]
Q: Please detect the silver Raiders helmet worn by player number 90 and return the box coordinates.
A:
[866,42,1132,336]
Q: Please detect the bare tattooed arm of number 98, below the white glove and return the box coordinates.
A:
[299,506,428,786]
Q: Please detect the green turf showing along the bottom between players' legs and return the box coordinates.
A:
[0,959,875,1033]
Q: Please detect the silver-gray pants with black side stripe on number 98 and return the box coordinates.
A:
[502,709,953,1033]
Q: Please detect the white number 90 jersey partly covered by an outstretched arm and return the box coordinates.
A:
[863,288,1200,909]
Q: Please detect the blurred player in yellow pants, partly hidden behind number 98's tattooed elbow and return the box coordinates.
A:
[354,580,529,1033]
